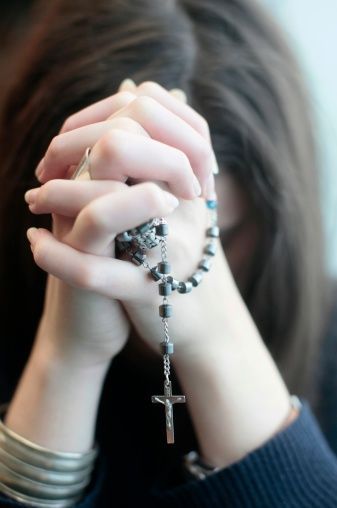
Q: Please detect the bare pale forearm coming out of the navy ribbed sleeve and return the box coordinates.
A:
[174,288,290,467]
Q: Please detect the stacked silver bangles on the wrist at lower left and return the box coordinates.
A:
[0,405,98,508]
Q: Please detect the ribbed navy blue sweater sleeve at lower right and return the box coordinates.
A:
[153,400,337,508]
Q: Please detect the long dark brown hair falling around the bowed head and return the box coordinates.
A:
[0,0,329,404]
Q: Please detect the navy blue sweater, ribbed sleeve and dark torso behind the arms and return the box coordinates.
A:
[0,300,337,508]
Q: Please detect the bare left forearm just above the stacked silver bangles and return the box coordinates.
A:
[5,320,108,452]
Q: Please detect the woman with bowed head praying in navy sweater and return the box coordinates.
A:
[1,0,337,507]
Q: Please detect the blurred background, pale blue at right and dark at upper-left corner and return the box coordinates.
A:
[0,0,337,276]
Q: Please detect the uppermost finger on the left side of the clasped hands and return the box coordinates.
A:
[60,90,136,134]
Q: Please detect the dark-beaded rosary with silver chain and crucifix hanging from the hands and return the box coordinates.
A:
[116,195,219,444]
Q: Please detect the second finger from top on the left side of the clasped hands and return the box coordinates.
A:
[36,117,149,182]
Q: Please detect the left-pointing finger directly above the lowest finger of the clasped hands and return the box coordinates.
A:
[25,179,124,218]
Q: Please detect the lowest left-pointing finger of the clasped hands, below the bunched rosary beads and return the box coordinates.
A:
[27,228,147,301]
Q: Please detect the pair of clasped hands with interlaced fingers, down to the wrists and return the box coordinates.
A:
[25,82,234,370]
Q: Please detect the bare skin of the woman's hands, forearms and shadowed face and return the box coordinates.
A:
[6,82,296,467]
